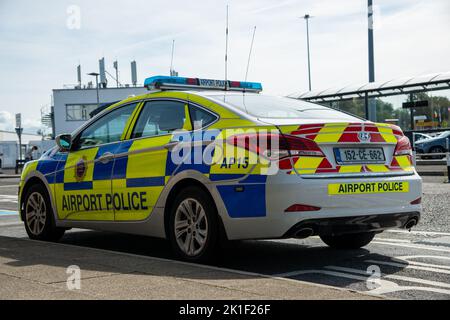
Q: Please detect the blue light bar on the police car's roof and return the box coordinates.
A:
[144,76,262,92]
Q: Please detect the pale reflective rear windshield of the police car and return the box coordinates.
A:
[210,94,356,121]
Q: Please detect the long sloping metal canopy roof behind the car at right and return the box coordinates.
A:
[289,72,450,102]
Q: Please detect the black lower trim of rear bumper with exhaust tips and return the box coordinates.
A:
[283,212,420,238]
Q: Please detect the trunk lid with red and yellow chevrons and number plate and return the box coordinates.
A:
[274,121,414,178]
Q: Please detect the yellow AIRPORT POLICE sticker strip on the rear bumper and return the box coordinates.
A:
[328,181,409,195]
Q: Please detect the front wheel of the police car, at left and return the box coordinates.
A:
[23,184,66,241]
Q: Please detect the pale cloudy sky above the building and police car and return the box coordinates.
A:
[0,0,450,132]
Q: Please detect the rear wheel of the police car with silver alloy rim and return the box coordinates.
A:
[168,186,219,262]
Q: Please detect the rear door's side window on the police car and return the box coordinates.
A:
[132,100,186,138]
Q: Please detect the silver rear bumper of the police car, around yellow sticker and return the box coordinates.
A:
[222,171,422,240]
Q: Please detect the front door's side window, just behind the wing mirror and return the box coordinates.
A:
[74,103,137,150]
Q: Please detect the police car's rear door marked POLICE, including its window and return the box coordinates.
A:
[112,99,191,221]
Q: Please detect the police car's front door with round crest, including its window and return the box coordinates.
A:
[55,103,136,221]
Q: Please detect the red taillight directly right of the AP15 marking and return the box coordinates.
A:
[228,133,325,159]
